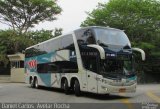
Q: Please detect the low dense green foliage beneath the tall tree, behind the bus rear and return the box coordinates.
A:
[0,28,62,66]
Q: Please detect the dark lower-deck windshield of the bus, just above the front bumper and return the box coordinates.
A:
[100,55,135,78]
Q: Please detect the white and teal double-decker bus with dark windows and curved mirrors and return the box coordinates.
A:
[25,26,145,96]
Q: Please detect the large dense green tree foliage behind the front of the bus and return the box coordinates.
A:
[81,0,160,76]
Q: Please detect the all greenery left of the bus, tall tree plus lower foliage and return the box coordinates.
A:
[0,0,62,72]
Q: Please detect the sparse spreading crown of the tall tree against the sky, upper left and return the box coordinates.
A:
[0,0,61,34]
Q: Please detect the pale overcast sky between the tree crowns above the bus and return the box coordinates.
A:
[0,0,109,33]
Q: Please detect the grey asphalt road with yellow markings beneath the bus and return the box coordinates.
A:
[0,83,160,109]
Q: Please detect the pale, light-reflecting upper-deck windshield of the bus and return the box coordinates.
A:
[94,28,131,46]
